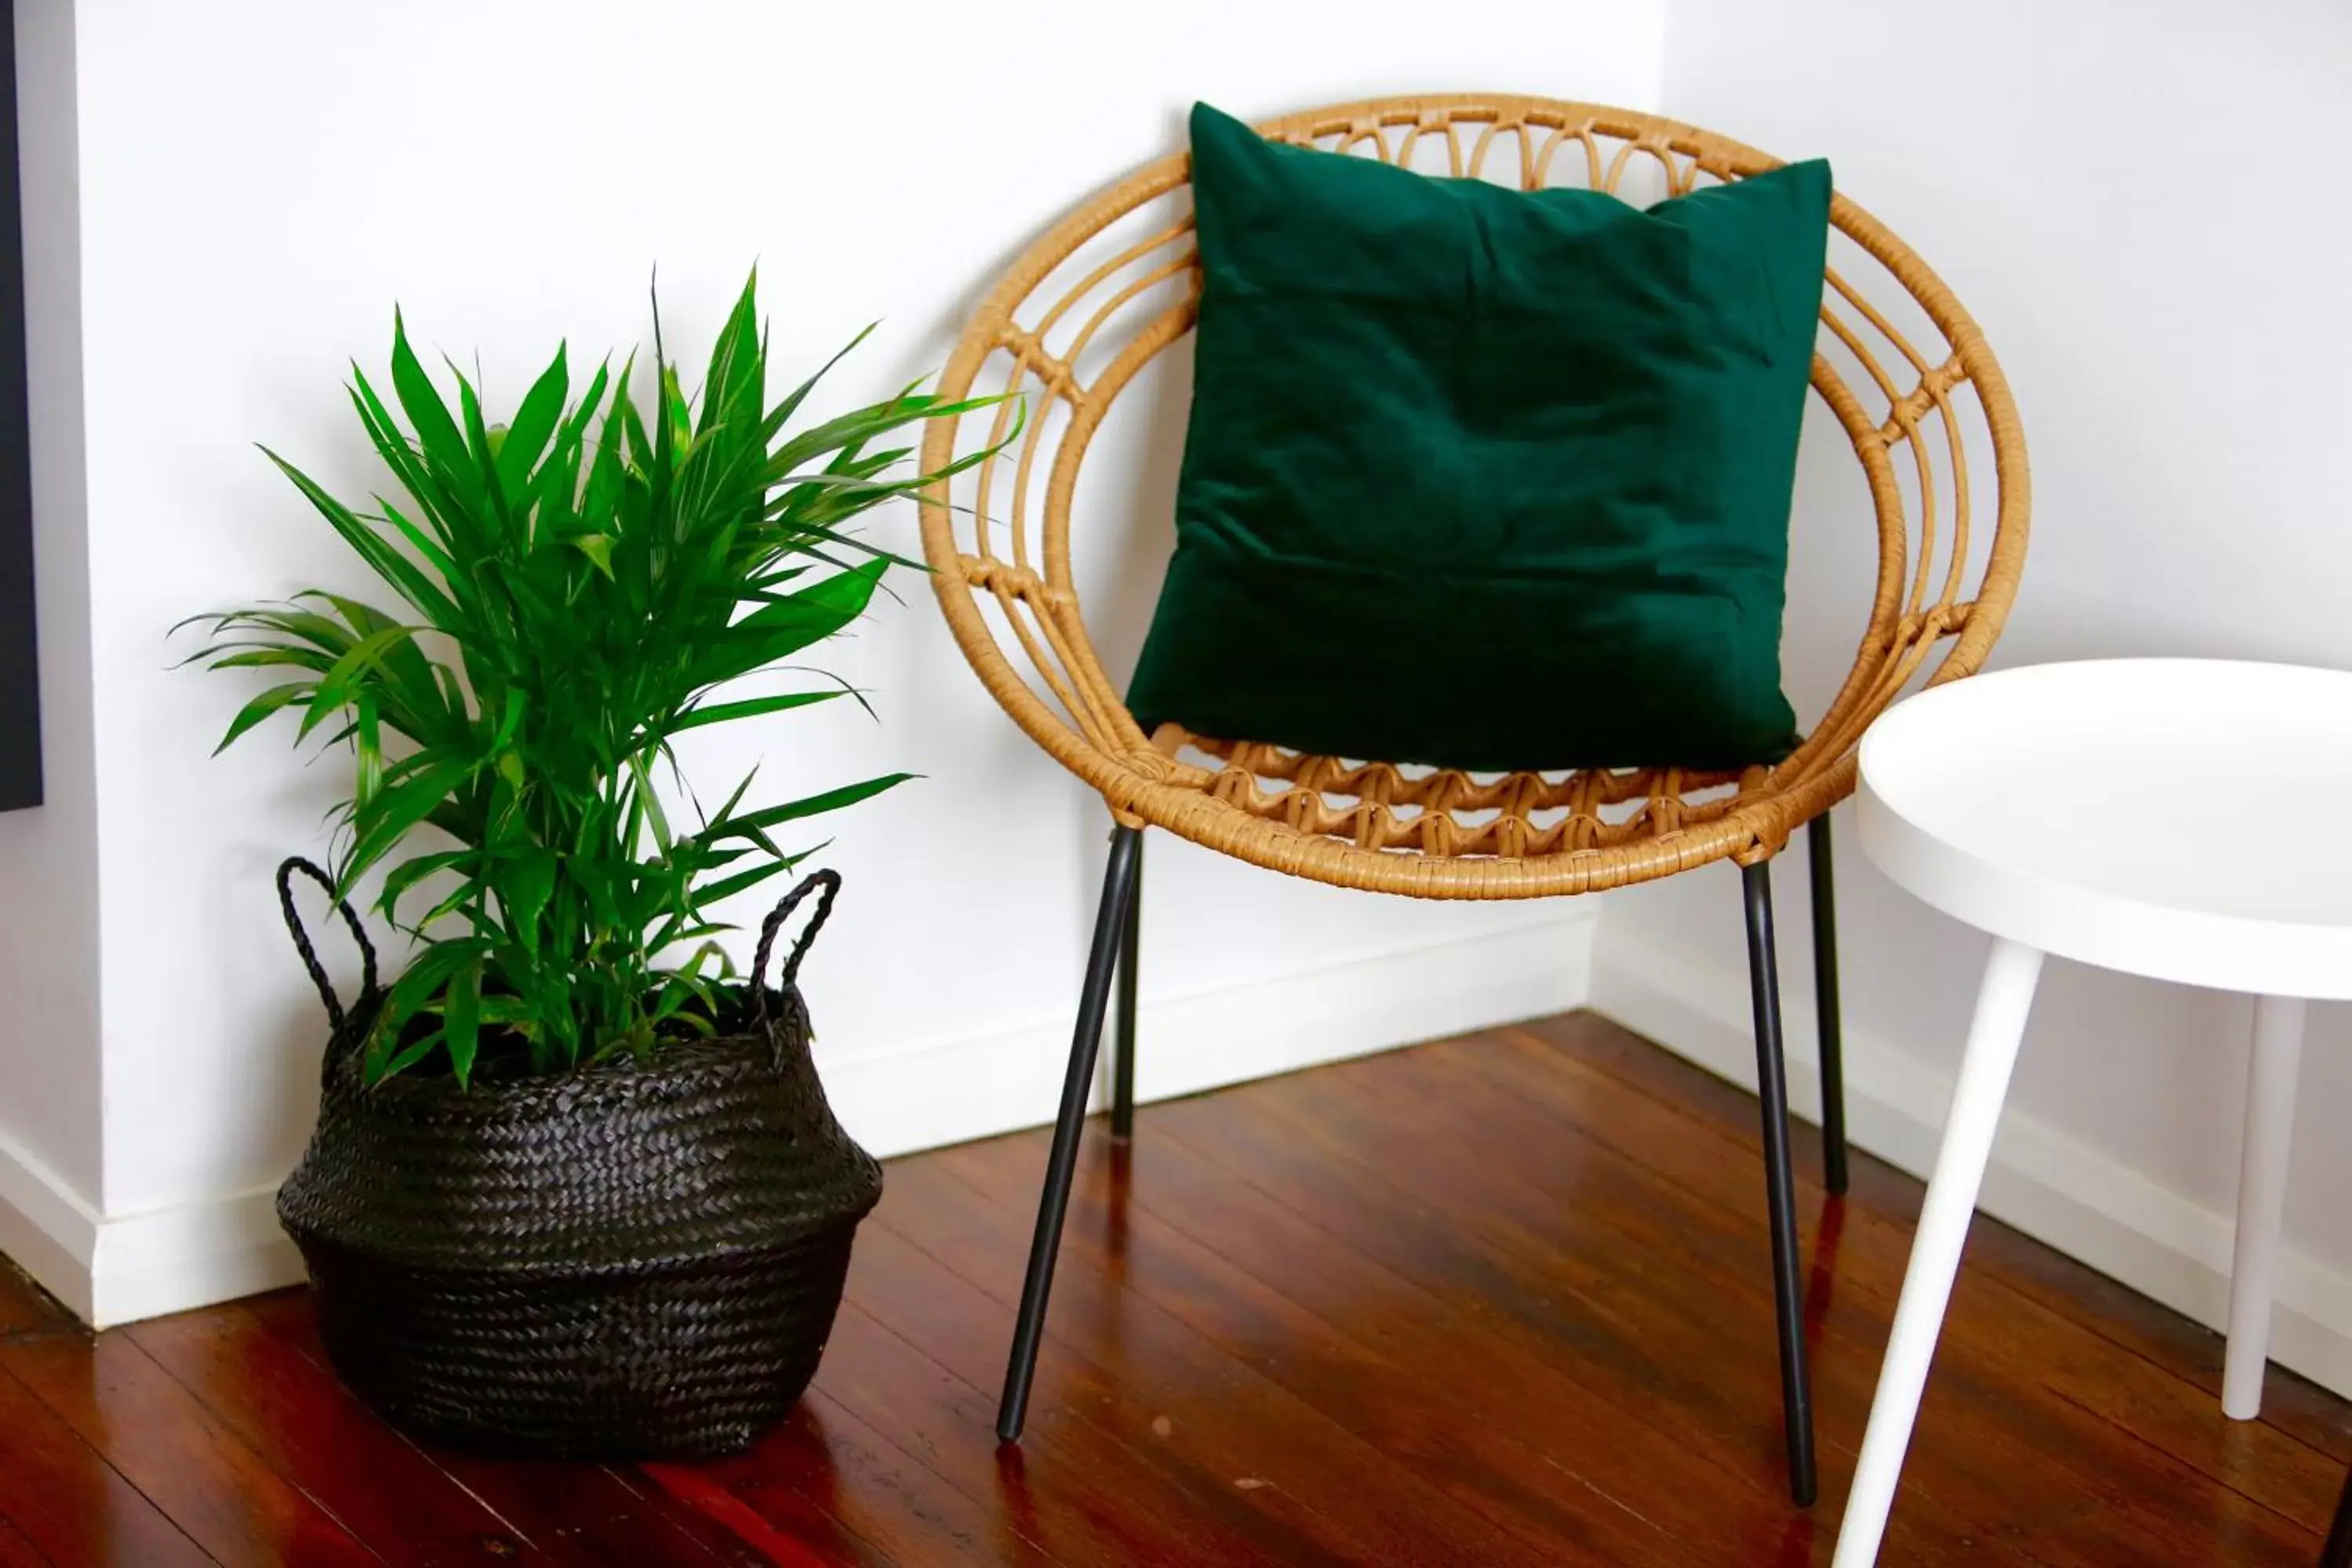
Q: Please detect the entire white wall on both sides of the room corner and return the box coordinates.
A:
[45,0,2352,1387]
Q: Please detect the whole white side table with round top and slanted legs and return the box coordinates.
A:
[1835,659,2352,1568]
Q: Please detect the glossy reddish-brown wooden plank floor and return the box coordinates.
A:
[0,1015,2352,1568]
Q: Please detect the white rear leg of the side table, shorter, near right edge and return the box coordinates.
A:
[2220,996,2305,1420]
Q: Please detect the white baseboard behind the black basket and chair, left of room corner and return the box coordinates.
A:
[0,905,1597,1328]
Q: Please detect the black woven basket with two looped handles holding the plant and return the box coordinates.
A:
[278,858,882,1457]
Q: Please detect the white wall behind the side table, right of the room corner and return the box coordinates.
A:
[1597,0,2352,1387]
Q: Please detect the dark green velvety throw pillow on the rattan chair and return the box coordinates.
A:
[1129,103,1830,769]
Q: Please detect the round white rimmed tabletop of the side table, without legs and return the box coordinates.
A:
[1856,659,2352,999]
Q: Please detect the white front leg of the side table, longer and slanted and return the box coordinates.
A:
[1835,938,2042,1568]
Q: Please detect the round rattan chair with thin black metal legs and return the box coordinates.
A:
[922,94,2027,1504]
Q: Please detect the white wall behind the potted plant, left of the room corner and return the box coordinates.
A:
[0,0,1663,1316]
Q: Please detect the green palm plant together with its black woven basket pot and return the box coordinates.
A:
[193,282,978,1457]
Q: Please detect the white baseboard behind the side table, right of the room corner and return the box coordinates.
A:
[1590,926,2352,1396]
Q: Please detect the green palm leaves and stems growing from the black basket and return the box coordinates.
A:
[176,278,990,1083]
